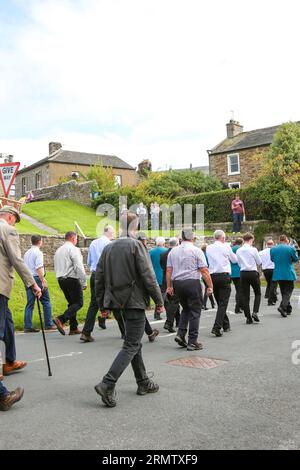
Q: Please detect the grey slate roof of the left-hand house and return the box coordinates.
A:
[18,149,135,174]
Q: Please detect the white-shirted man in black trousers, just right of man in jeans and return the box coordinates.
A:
[54,232,86,335]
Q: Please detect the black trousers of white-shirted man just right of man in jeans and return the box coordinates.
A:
[58,277,83,331]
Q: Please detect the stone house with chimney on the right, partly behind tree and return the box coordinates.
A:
[207,119,296,188]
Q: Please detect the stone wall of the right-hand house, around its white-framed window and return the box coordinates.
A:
[209,146,269,187]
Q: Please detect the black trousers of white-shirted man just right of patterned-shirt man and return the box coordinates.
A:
[211,273,231,330]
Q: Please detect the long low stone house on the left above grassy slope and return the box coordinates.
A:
[16,142,137,198]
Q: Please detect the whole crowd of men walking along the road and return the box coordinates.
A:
[0,206,299,411]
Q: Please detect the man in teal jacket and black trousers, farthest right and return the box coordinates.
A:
[270,235,299,318]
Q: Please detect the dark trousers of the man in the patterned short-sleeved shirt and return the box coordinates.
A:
[173,279,203,344]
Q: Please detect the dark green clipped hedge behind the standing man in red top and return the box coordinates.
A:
[175,188,268,222]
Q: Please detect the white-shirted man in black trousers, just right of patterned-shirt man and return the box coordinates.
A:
[206,230,237,337]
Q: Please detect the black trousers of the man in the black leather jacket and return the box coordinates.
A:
[103,309,148,386]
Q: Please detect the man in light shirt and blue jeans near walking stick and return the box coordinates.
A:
[24,235,56,333]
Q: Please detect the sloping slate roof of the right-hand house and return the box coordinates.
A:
[208,122,300,155]
